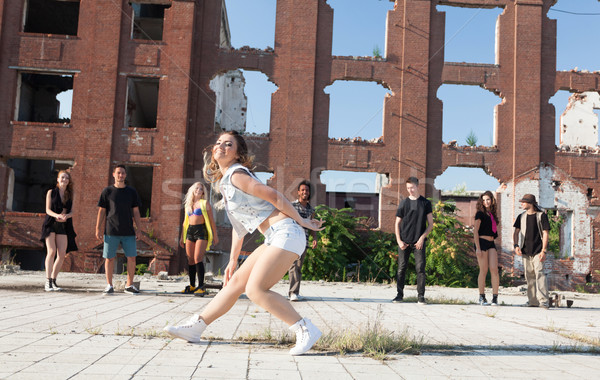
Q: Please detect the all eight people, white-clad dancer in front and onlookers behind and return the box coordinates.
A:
[42,132,549,355]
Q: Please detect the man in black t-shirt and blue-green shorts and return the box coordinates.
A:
[96,165,142,294]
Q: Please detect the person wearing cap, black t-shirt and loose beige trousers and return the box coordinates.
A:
[513,194,550,308]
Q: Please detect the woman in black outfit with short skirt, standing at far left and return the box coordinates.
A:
[40,170,77,292]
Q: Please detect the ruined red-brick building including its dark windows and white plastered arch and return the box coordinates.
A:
[0,0,600,288]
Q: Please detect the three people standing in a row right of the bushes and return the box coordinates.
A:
[392,177,550,308]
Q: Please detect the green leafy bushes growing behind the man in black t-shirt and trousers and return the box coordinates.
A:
[302,201,479,287]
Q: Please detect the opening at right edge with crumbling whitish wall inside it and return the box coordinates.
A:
[549,91,600,151]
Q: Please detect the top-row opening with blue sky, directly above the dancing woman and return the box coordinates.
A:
[221,0,277,49]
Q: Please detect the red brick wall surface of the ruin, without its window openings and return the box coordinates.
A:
[0,0,600,290]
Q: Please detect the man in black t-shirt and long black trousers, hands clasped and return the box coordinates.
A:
[392,177,433,304]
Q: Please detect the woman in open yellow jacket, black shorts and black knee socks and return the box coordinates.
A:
[179,182,219,297]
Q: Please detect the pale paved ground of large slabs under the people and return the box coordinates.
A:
[0,272,600,380]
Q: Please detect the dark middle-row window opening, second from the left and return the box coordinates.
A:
[125,78,159,128]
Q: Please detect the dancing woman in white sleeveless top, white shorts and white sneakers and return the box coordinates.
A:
[165,132,323,355]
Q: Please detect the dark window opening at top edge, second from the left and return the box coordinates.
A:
[131,1,170,41]
